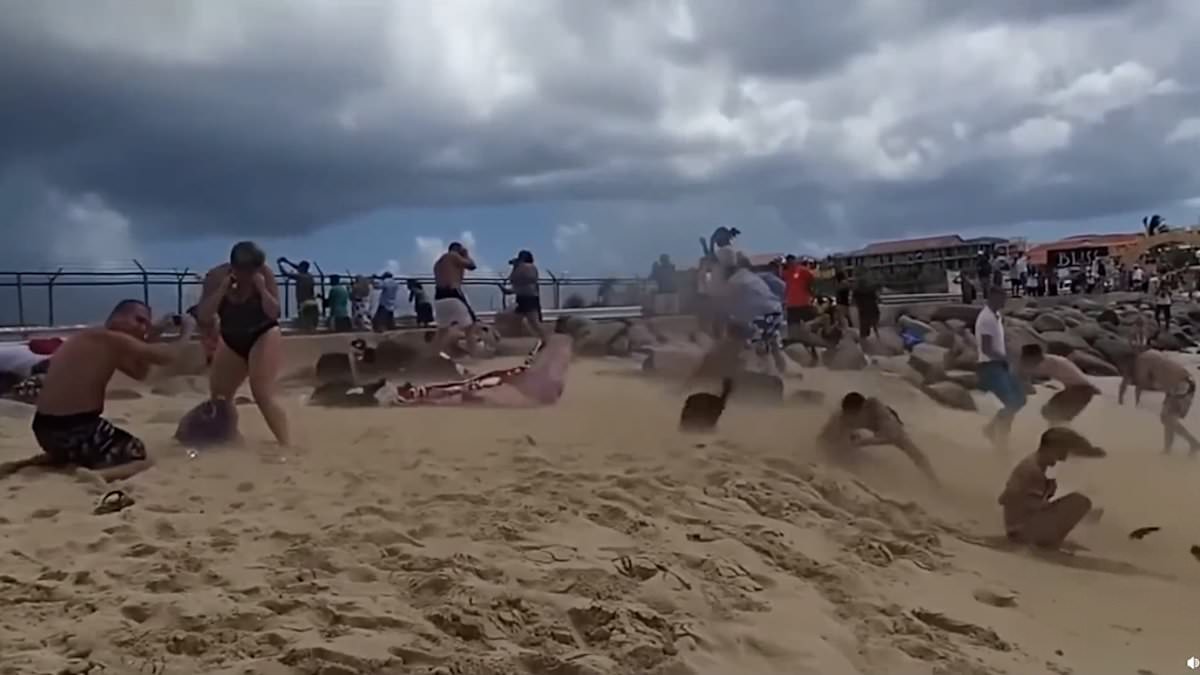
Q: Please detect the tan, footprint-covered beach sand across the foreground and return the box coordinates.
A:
[0,348,1200,675]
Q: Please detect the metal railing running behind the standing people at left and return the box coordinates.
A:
[0,261,649,333]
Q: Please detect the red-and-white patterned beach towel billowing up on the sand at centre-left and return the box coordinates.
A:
[391,317,582,407]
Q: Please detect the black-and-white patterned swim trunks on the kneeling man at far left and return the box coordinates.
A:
[34,412,146,468]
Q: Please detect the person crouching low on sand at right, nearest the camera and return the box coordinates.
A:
[1000,426,1092,549]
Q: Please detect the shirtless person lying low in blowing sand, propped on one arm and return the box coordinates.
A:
[817,392,938,483]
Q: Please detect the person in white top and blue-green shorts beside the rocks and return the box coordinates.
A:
[974,285,1025,448]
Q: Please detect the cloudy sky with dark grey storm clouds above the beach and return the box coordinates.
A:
[0,0,1200,268]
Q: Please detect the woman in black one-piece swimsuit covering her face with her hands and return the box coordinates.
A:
[198,241,289,446]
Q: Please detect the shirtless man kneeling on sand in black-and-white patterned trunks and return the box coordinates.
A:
[0,300,173,480]
